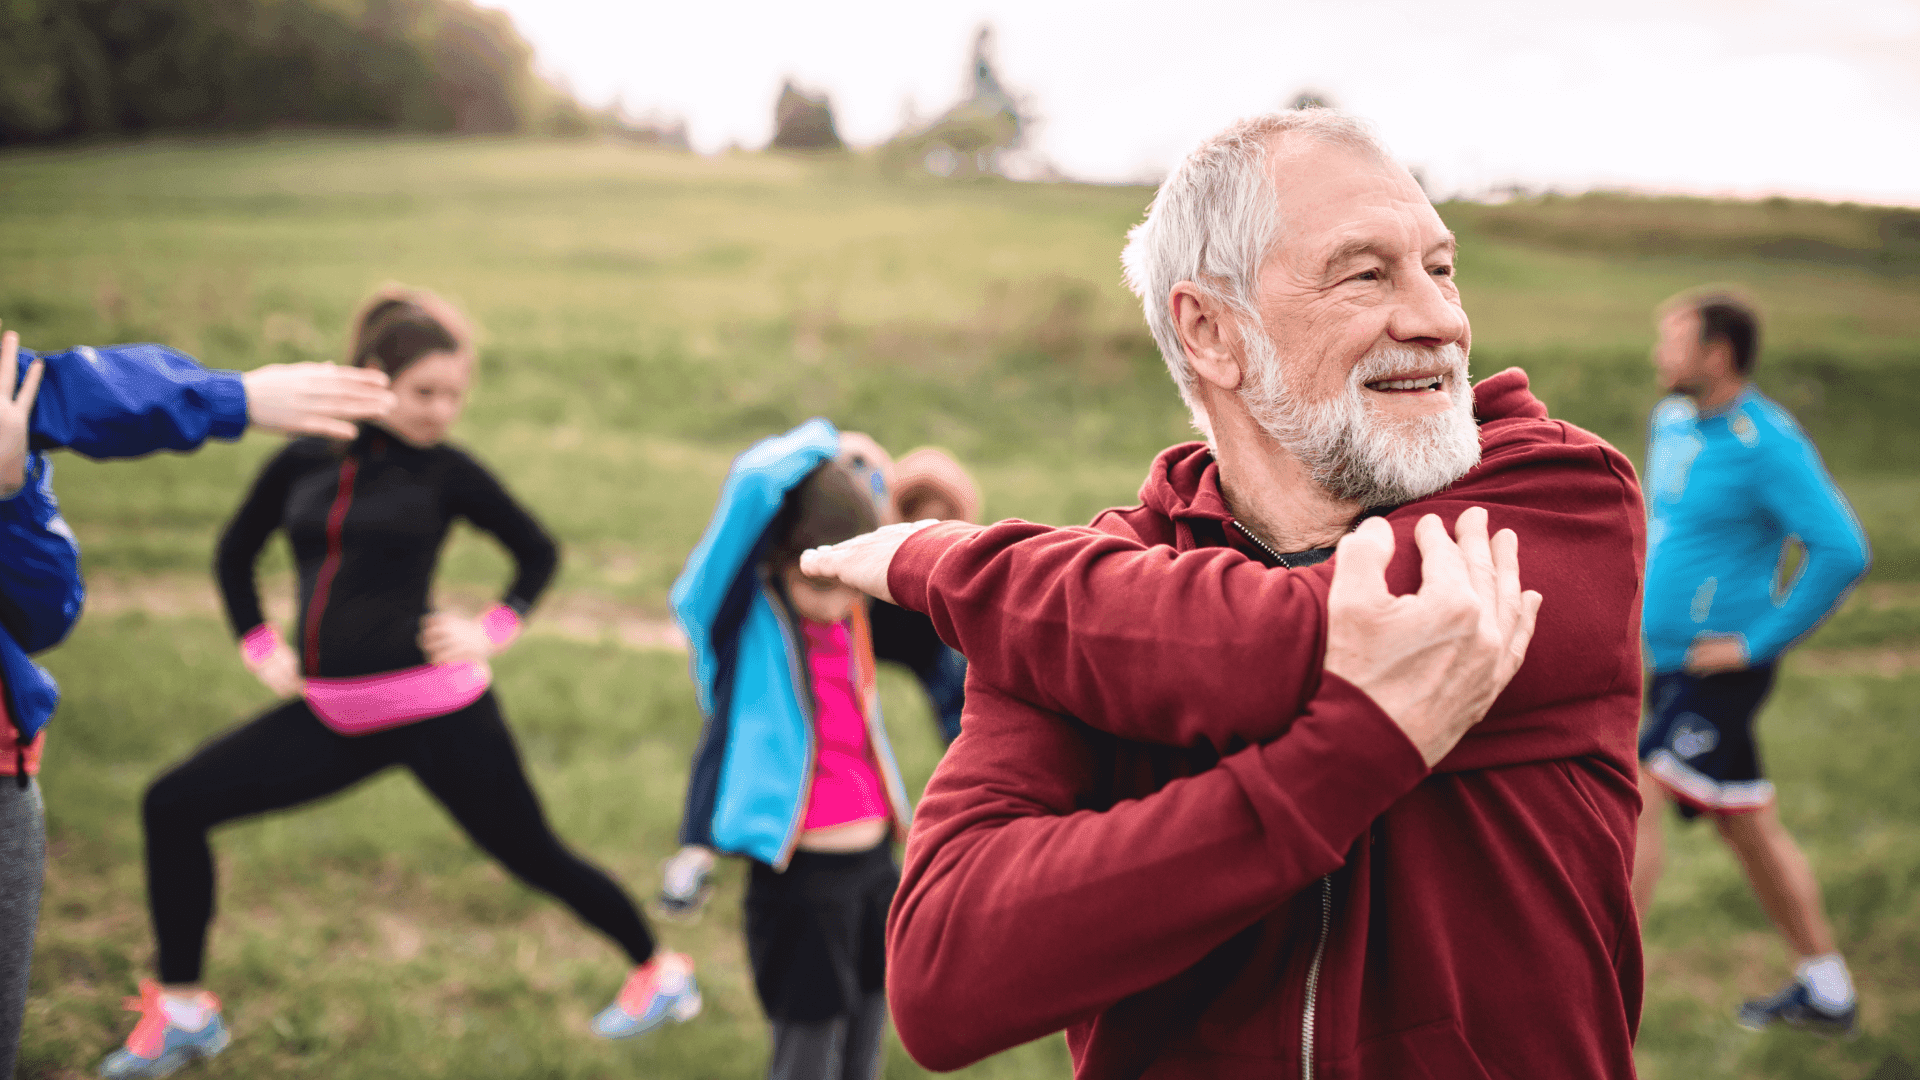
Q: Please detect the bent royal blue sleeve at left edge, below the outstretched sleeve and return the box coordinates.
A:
[0,454,86,653]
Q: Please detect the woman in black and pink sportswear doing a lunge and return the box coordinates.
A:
[100,288,701,1078]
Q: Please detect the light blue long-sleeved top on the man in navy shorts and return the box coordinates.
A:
[1642,386,1866,673]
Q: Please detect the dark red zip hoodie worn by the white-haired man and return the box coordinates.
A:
[887,369,1645,1080]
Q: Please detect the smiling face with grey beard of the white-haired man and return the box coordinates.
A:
[1238,140,1480,507]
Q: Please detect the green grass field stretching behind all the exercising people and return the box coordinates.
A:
[0,136,1920,1080]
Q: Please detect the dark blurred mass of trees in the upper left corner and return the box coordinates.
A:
[0,0,591,144]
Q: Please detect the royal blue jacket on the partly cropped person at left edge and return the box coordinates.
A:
[0,346,246,742]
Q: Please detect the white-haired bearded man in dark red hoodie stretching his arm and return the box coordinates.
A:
[803,110,1645,1080]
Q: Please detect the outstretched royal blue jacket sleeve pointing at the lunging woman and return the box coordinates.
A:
[21,338,246,457]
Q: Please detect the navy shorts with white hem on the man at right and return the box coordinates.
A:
[1640,663,1774,817]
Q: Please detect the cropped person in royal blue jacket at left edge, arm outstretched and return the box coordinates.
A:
[0,320,392,1076]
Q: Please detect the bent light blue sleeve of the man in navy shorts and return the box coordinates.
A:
[1747,417,1868,663]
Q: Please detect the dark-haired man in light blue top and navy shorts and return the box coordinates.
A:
[1634,292,1866,1034]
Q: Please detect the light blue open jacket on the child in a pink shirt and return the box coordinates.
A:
[672,419,908,871]
